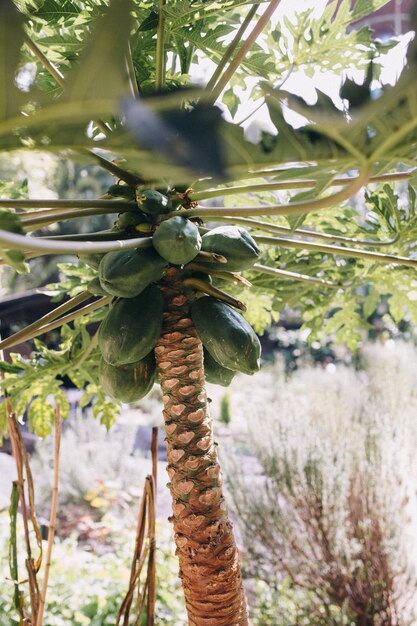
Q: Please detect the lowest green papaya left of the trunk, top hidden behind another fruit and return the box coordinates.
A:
[98,351,156,403]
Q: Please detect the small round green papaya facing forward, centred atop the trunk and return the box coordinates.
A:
[152,215,201,265]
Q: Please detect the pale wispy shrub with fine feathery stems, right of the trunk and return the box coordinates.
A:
[228,342,417,626]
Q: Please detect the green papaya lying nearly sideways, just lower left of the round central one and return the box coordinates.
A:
[98,248,168,298]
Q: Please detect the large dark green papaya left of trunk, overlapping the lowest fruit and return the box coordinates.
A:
[98,285,164,365]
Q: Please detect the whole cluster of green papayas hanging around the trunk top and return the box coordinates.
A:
[84,185,260,402]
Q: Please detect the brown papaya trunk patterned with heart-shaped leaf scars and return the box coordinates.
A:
[155,270,248,626]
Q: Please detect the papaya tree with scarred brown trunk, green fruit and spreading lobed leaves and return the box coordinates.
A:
[0,0,417,626]
